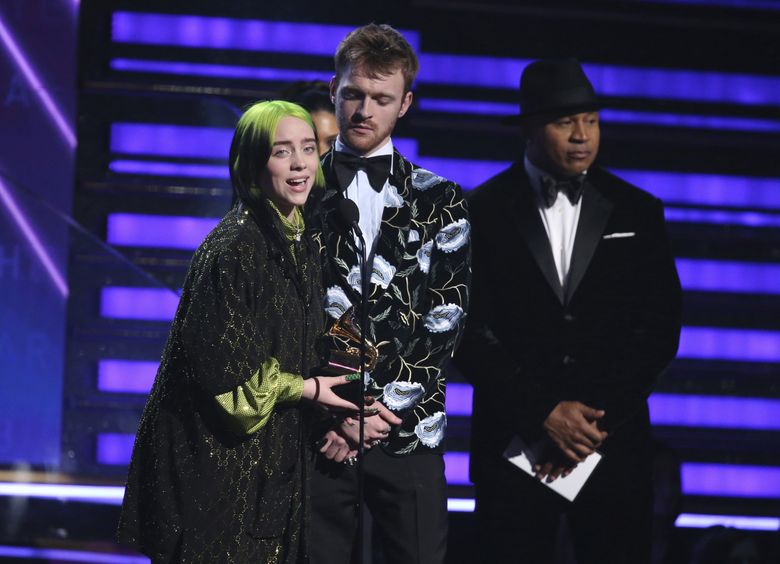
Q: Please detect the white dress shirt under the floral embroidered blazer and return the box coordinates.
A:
[333,138,393,258]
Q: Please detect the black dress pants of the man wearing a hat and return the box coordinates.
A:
[475,442,653,564]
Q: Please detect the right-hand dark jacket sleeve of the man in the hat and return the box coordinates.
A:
[586,196,682,432]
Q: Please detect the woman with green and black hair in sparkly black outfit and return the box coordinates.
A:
[119,101,359,564]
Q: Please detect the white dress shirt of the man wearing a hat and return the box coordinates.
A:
[524,157,587,291]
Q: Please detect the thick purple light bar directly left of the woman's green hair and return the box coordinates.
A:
[110,123,233,162]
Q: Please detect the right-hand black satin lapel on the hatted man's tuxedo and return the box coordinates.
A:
[566,180,614,303]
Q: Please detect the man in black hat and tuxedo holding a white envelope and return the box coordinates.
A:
[456,59,681,564]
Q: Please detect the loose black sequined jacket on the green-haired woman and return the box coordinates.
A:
[118,200,323,563]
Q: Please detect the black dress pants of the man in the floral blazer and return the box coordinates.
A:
[308,448,447,564]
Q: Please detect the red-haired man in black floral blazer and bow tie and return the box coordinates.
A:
[311,24,470,564]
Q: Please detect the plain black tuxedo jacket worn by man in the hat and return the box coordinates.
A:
[456,161,681,482]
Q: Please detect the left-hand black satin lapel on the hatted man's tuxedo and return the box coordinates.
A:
[510,164,564,303]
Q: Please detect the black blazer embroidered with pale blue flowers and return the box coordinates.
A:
[309,151,471,454]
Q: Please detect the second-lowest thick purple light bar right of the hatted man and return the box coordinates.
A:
[648,393,780,431]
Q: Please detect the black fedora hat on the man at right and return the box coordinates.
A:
[504,59,602,123]
